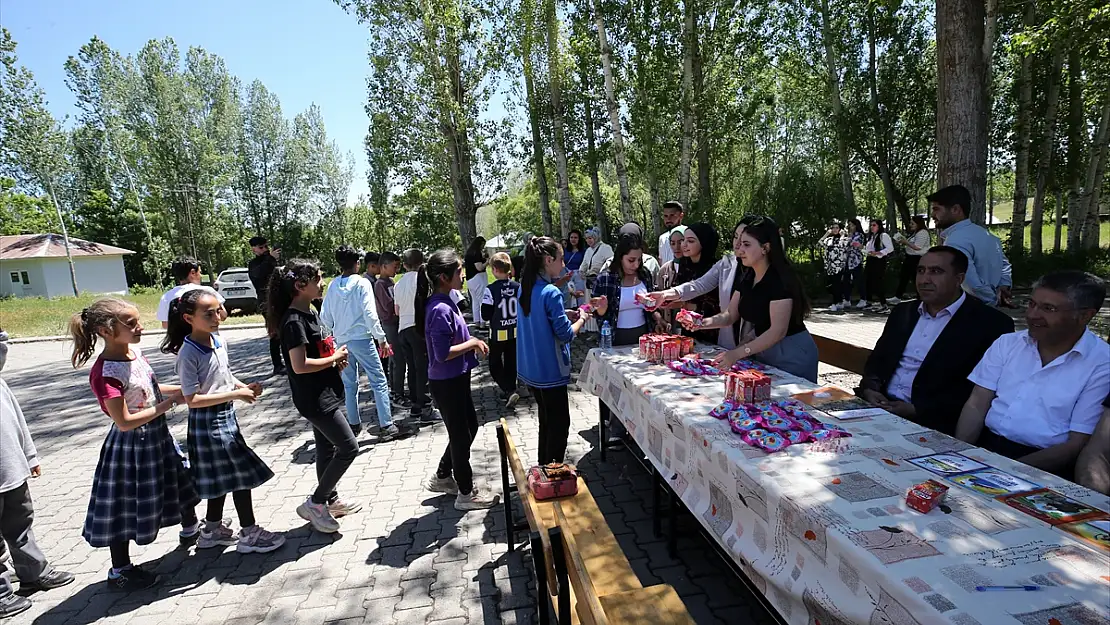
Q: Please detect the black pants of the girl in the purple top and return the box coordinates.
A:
[427,371,478,493]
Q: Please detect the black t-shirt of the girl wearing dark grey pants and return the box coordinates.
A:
[281,308,343,415]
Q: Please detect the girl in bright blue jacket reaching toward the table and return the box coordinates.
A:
[516,234,607,464]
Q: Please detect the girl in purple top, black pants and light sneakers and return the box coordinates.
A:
[416,250,500,511]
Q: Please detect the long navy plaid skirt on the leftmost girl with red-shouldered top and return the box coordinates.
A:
[81,416,200,547]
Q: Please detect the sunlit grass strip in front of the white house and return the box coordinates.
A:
[0,289,263,339]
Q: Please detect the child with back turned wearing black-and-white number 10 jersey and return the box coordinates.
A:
[482,252,521,407]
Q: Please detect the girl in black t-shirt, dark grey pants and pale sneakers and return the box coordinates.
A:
[266,259,362,534]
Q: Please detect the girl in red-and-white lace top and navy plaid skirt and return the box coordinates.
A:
[70,298,200,591]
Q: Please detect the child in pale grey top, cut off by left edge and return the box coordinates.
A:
[0,330,73,618]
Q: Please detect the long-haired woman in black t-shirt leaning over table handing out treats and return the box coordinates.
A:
[679,218,817,383]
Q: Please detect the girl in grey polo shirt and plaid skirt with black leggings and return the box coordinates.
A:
[162,289,285,553]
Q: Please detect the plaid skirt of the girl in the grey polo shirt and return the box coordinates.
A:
[189,402,274,500]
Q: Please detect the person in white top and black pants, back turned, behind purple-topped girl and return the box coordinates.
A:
[393,249,436,422]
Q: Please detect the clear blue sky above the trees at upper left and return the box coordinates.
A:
[0,0,377,199]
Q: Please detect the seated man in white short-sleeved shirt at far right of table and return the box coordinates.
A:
[956,271,1110,477]
